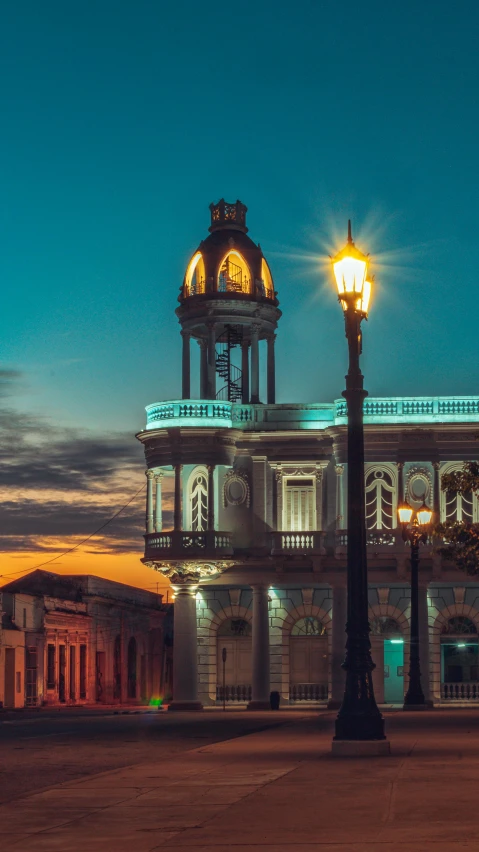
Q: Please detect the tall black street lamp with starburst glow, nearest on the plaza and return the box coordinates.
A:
[332,222,389,754]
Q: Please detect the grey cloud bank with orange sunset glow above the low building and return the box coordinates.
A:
[0,370,176,554]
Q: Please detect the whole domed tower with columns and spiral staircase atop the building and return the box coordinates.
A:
[176,198,281,403]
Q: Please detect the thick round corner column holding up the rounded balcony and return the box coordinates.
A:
[168,585,203,711]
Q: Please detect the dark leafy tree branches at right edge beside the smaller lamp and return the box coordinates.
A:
[435,461,479,575]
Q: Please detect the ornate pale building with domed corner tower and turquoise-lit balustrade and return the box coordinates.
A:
[137,199,479,710]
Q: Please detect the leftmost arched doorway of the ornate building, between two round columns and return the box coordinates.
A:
[216,618,251,703]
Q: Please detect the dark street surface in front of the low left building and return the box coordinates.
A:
[0,708,292,803]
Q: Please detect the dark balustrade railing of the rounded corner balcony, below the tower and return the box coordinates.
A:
[145,530,233,559]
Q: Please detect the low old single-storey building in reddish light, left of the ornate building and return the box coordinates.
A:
[0,571,171,708]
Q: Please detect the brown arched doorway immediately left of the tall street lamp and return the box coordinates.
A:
[289,615,329,702]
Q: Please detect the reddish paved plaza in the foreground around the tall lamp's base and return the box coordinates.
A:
[0,709,479,852]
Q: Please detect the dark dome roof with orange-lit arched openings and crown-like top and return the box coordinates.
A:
[179,198,277,304]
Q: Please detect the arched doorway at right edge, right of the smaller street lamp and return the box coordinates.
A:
[441,615,479,701]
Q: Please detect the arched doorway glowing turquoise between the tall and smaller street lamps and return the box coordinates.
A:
[370,615,404,704]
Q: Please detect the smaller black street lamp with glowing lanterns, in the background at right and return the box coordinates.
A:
[398,501,432,710]
